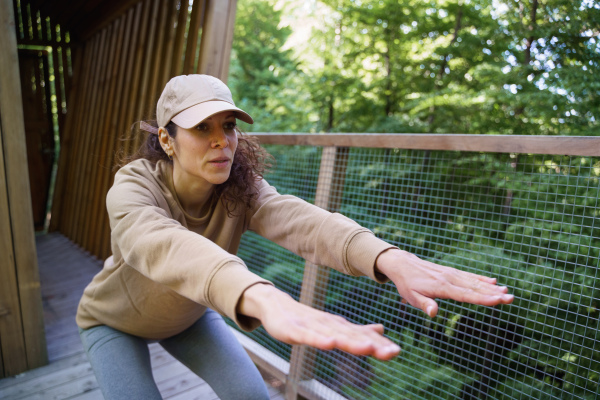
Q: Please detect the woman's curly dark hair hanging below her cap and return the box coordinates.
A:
[117,120,274,217]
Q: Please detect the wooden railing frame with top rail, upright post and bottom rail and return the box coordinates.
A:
[239,133,600,400]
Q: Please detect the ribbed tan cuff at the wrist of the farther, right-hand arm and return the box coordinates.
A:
[346,231,398,283]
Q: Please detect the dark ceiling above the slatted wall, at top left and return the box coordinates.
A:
[22,0,140,41]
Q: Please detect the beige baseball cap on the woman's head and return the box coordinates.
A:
[156,75,254,129]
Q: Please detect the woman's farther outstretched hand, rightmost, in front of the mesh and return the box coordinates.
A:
[375,249,514,318]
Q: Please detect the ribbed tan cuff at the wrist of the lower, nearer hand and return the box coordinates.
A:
[207,261,273,332]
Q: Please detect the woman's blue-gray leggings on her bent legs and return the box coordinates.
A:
[79,310,269,400]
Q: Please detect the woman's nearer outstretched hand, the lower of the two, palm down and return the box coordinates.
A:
[237,284,400,360]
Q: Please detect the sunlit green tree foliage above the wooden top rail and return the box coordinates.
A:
[230,0,600,135]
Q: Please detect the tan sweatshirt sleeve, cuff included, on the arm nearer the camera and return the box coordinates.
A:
[107,165,270,330]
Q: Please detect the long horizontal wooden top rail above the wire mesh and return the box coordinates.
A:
[252,133,600,157]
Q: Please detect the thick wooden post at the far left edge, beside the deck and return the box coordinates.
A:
[0,0,48,375]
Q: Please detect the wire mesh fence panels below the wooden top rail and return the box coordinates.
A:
[239,141,600,400]
